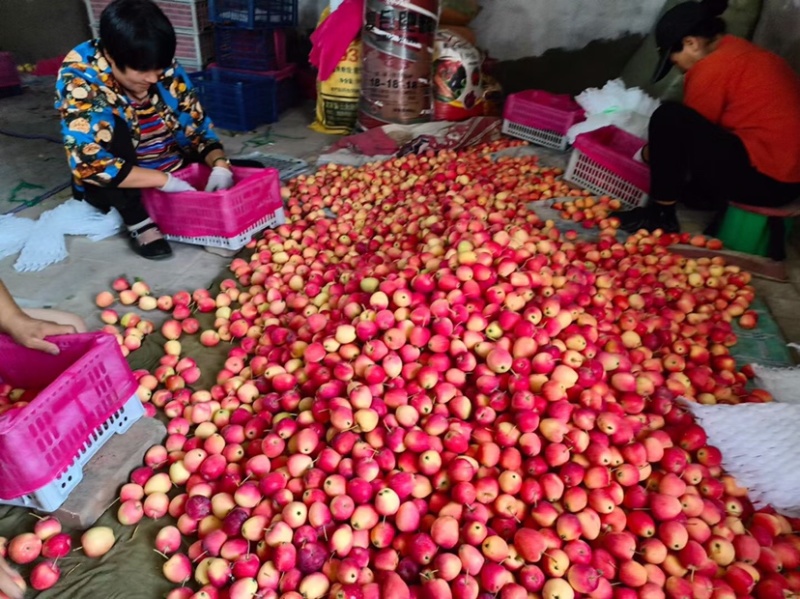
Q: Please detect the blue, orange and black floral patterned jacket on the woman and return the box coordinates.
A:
[55,40,222,191]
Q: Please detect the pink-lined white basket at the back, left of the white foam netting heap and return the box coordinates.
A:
[503,89,585,151]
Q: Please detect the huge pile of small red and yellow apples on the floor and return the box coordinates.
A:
[53,141,800,599]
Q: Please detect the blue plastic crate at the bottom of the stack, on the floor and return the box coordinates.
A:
[191,65,295,131]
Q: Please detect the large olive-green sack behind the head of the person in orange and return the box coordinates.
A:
[622,0,762,101]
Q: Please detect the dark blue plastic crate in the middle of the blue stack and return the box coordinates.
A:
[214,26,286,71]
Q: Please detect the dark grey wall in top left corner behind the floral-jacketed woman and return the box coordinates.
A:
[0,0,90,63]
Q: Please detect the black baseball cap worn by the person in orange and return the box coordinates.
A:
[653,0,728,83]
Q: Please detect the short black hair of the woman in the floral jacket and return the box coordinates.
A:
[100,0,176,71]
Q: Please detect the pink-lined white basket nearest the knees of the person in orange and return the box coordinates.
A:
[564,126,650,208]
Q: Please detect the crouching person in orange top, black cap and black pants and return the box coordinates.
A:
[615,0,800,232]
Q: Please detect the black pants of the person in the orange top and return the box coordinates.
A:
[649,102,800,210]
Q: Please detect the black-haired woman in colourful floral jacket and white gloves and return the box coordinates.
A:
[56,0,233,259]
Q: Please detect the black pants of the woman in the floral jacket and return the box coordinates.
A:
[75,116,264,226]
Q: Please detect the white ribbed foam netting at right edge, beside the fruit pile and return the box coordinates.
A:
[681,399,800,517]
